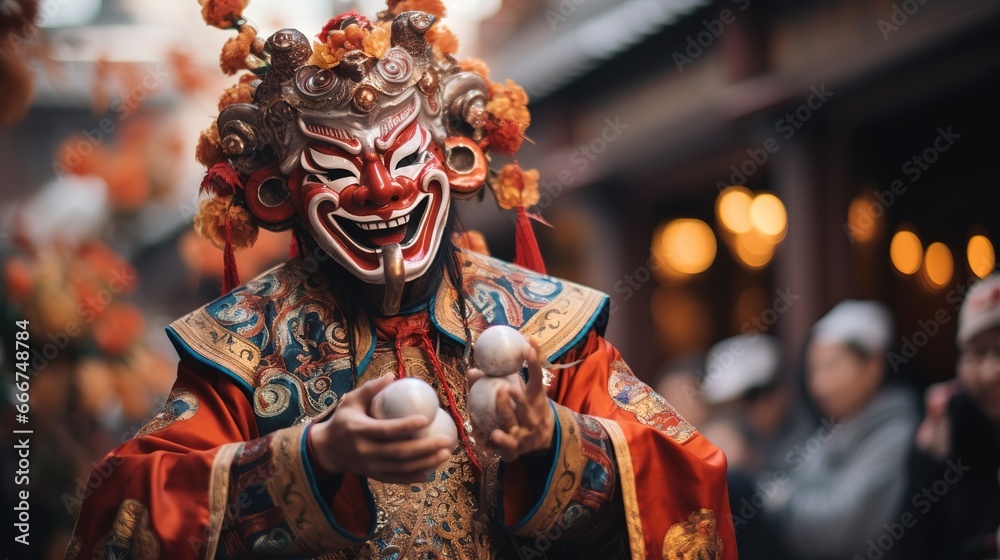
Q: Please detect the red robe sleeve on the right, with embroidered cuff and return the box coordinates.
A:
[503,331,737,560]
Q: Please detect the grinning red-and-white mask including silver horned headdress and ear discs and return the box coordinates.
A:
[217,20,488,288]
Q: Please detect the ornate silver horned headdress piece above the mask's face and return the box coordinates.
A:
[218,12,488,175]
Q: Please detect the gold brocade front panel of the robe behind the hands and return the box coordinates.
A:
[324,347,498,559]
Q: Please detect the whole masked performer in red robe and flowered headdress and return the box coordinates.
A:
[67,0,736,559]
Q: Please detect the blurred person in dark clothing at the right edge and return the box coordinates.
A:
[901,275,1000,560]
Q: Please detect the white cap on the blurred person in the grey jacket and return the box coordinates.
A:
[812,299,893,354]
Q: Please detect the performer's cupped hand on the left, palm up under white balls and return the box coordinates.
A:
[309,374,454,484]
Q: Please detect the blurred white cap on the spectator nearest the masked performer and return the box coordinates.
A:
[701,334,781,404]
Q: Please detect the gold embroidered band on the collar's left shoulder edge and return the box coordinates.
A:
[170,309,260,387]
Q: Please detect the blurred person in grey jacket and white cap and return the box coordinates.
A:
[767,300,918,559]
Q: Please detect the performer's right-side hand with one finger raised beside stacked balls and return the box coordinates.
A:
[470,342,555,463]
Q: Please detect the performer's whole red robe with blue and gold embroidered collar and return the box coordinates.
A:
[67,253,737,559]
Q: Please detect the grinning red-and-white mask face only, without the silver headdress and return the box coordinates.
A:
[290,98,451,284]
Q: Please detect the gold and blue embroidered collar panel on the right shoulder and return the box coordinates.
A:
[434,251,607,357]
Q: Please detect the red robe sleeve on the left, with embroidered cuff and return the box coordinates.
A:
[66,363,375,559]
